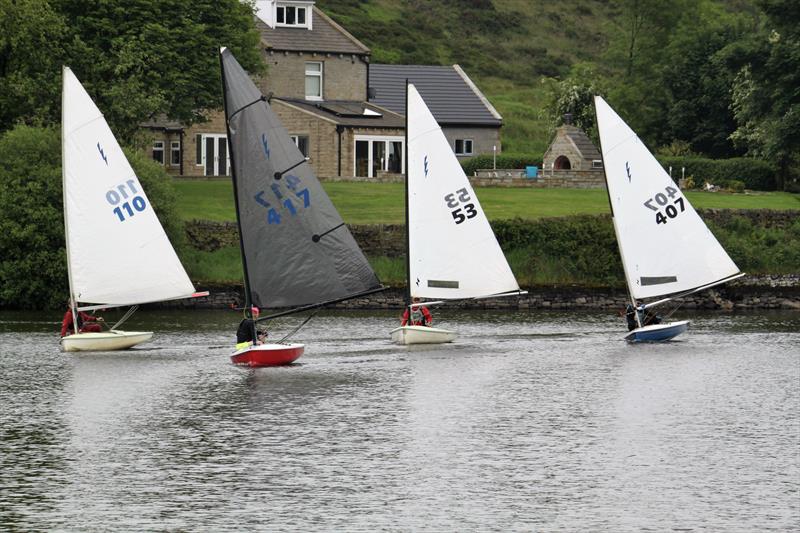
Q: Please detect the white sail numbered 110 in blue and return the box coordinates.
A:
[62,67,194,306]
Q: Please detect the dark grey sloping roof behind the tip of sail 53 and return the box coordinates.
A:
[369,64,503,126]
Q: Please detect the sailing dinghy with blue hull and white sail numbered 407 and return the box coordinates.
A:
[594,96,744,342]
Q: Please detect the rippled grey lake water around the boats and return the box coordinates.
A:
[0,311,800,531]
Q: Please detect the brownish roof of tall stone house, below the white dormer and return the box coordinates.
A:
[256,6,369,55]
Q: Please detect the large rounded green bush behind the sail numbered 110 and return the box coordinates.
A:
[0,126,183,309]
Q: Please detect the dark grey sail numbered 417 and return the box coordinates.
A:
[220,49,381,307]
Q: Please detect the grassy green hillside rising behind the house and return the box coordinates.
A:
[317,0,764,153]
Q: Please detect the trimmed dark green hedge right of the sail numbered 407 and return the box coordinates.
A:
[658,156,777,191]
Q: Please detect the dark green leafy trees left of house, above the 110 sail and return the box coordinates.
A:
[0,0,264,141]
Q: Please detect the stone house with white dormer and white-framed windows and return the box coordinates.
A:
[143,0,501,178]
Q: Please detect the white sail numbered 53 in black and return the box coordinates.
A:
[406,84,519,299]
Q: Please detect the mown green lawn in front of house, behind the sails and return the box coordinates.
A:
[174,179,800,224]
